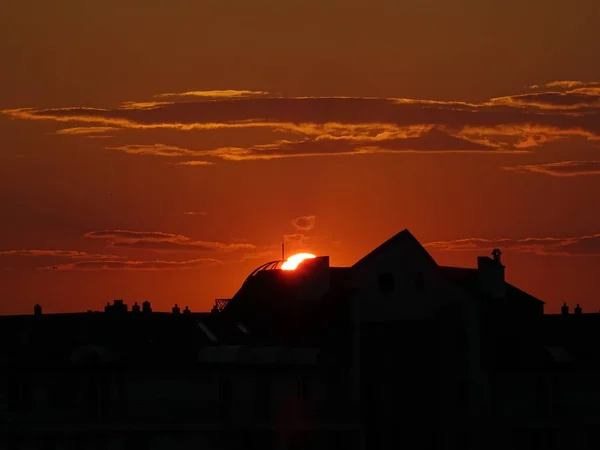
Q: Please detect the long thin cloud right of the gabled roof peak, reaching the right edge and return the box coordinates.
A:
[425,234,600,256]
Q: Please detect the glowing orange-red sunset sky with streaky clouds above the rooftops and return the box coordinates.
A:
[0,0,600,314]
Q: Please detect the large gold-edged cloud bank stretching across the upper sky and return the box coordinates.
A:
[1,81,600,157]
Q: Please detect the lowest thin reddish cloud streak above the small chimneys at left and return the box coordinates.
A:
[42,259,222,271]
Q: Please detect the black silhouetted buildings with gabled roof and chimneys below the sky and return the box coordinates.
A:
[0,230,600,450]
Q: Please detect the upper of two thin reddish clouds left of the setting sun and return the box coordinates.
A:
[84,230,256,252]
